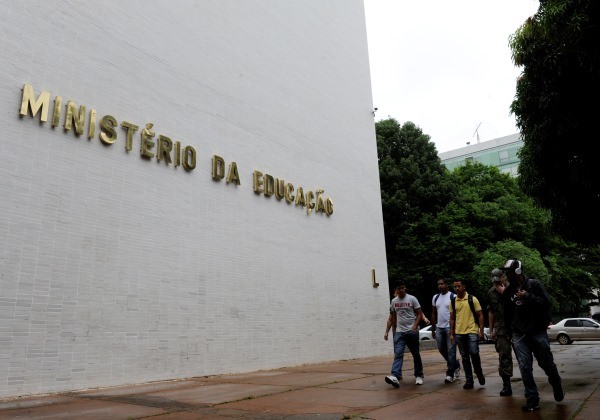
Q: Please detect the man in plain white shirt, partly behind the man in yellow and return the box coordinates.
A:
[431,278,460,384]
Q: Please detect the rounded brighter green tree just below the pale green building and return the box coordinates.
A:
[431,163,549,278]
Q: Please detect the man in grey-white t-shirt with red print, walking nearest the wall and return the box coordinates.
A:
[385,281,423,388]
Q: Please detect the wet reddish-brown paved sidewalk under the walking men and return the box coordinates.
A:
[0,342,600,420]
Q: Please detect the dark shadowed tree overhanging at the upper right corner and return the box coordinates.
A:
[509,0,600,244]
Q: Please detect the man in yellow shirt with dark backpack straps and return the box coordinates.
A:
[450,280,485,389]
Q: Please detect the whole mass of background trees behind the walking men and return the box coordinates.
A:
[376,118,600,322]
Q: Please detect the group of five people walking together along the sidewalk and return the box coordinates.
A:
[384,259,564,411]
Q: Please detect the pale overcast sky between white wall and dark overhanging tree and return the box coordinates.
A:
[364,0,539,152]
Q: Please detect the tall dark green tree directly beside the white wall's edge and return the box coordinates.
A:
[375,118,453,295]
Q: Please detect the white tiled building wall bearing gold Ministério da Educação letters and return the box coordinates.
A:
[0,0,392,397]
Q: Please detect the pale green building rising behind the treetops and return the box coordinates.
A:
[439,133,523,176]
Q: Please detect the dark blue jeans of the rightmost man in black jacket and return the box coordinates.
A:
[512,331,560,400]
